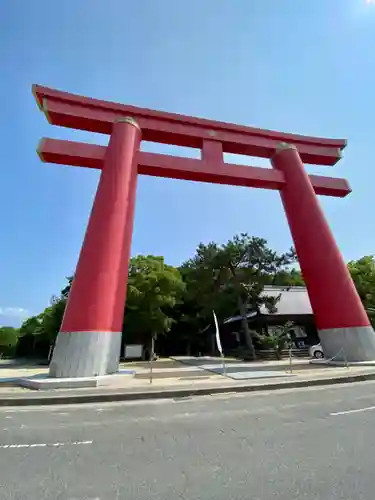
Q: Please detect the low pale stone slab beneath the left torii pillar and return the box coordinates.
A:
[17,370,135,391]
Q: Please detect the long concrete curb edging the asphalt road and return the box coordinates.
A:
[0,372,375,406]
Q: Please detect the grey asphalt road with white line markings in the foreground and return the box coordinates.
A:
[0,382,375,500]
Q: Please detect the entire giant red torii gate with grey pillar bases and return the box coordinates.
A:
[33,85,375,377]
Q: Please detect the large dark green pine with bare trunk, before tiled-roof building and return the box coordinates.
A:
[183,234,296,358]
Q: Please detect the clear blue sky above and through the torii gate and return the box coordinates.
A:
[0,0,375,325]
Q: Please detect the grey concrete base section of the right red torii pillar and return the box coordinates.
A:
[319,326,375,362]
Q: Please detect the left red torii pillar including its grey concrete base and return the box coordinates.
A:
[50,118,141,377]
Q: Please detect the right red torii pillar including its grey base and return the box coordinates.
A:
[272,143,375,359]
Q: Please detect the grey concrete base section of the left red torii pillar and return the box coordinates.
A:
[49,332,121,378]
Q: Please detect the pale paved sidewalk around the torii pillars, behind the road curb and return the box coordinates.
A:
[0,357,375,404]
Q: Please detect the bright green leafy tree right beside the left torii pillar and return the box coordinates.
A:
[124,255,185,350]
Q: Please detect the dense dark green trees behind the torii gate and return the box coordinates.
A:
[0,234,375,357]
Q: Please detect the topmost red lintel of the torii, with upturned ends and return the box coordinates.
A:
[33,85,346,165]
